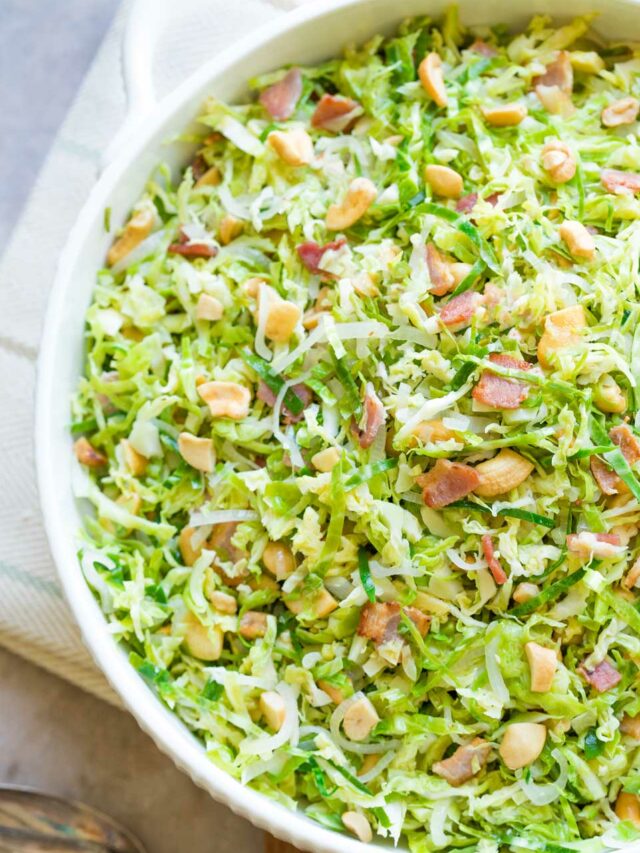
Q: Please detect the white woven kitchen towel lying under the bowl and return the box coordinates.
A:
[0,0,299,702]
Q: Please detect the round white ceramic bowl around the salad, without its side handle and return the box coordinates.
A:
[35,0,640,853]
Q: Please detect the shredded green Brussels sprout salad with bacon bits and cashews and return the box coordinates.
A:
[72,9,640,853]
